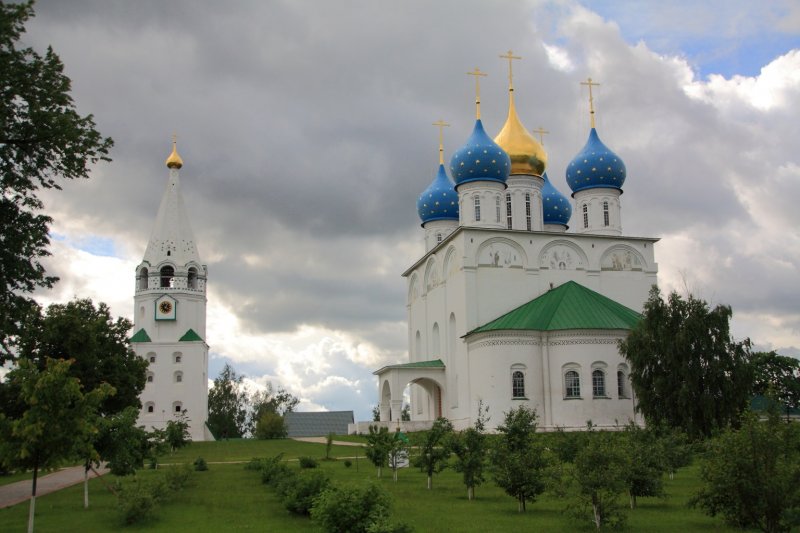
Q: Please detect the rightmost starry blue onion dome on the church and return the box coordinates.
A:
[567,128,626,193]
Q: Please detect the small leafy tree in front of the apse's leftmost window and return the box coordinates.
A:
[491,405,548,512]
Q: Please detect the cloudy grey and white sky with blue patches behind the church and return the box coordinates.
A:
[24,0,800,420]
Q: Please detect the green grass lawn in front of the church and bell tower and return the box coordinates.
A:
[0,440,756,533]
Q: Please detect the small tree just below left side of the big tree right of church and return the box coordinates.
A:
[621,422,667,509]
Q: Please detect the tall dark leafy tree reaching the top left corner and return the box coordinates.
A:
[0,2,113,362]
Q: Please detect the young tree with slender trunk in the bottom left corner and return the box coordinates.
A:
[0,359,113,532]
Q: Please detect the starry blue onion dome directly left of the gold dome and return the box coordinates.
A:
[450,119,511,186]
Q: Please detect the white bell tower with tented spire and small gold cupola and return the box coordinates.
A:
[131,138,213,440]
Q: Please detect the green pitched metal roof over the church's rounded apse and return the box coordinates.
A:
[465,281,641,336]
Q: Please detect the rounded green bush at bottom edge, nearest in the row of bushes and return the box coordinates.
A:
[311,484,391,533]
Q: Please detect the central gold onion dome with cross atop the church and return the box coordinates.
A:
[494,50,547,176]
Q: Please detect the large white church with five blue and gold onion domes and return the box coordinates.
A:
[372,67,658,430]
